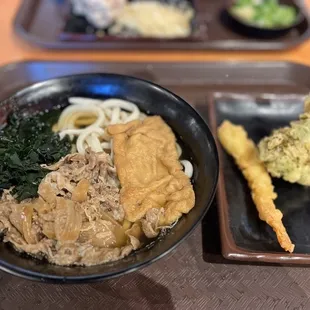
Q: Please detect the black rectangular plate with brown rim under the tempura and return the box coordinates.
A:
[214,94,310,261]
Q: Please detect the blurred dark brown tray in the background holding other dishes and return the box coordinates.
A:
[14,0,310,50]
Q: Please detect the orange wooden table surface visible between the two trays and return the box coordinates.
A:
[0,0,310,65]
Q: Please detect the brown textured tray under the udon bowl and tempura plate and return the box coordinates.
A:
[0,62,310,310]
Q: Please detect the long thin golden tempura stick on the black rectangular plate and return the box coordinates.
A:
[218,121,295,253]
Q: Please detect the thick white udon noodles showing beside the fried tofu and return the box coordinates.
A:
[53,97,193,178]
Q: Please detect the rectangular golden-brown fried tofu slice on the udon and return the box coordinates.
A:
[107,116,195,226]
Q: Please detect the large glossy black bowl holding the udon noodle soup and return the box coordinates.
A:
[0,74,219,283]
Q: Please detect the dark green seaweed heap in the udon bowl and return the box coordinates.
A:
[0,113,71,201]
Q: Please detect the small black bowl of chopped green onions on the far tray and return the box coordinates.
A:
[222,0,306,39]
